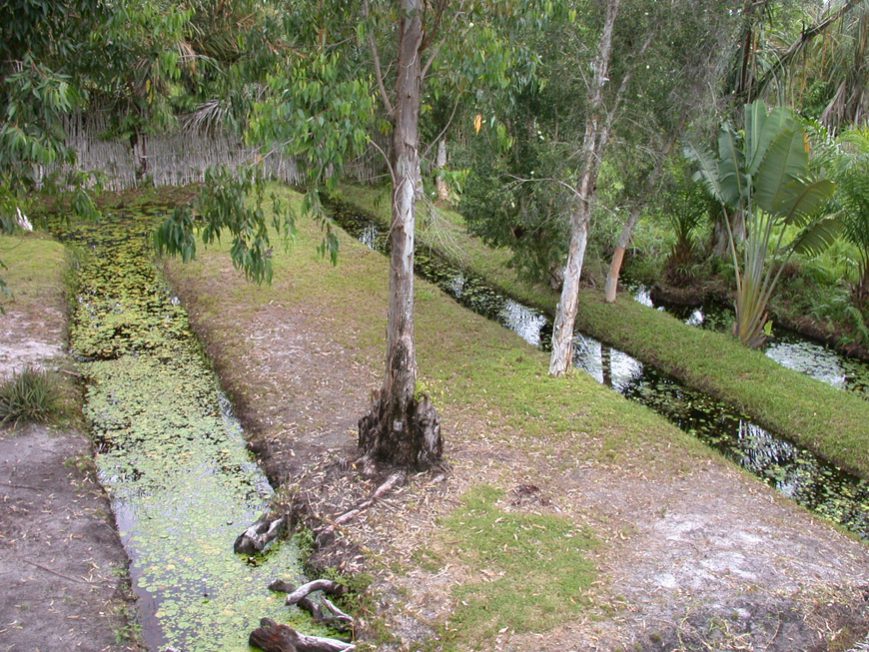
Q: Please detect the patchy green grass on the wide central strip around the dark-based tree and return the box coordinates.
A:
[169,185,724,649]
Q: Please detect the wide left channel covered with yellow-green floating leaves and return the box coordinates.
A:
[45,215,316,652]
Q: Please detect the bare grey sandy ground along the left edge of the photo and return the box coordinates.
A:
[0,236,140,652]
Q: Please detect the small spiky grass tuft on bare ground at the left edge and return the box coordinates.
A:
[0,367,61,426]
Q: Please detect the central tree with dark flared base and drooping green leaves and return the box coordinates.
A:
[157,0,547,468]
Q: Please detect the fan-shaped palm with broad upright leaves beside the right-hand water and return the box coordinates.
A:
[685,101,840,348]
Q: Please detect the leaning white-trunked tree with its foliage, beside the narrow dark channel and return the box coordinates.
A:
[549,0,721,376]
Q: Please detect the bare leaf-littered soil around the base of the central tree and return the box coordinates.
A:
[173,252,869,651]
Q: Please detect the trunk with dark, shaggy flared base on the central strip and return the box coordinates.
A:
[359,0,443,468]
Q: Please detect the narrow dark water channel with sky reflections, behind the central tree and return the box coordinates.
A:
[334,204,869,540]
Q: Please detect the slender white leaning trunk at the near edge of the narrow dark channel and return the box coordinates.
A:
[549,0,624,376]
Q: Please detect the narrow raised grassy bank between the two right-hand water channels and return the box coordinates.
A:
[342,186,869,478]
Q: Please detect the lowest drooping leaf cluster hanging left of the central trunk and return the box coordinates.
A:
[154,168,298,283]
